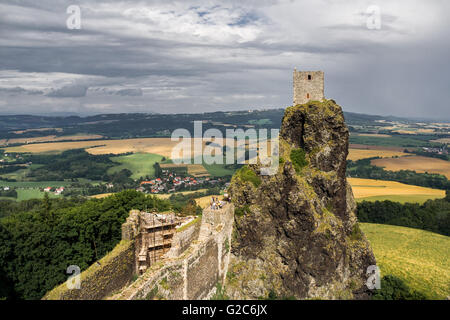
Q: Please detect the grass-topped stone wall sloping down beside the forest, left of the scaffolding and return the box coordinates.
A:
[43,240,135,300]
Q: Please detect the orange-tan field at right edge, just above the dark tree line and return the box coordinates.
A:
[371,156,450,179]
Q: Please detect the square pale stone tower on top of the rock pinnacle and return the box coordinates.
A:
[294,69,324,106]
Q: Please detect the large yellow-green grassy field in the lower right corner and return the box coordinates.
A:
[360,223,450,299]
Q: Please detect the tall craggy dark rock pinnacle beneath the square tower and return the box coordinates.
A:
[225,100,376,299]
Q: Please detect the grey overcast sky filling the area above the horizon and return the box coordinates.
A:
[0,0,450,119]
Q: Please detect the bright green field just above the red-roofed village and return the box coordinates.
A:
[108,153,163,179]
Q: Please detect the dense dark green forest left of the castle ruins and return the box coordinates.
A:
[0,190,174,299]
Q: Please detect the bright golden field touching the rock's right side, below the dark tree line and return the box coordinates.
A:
[347,178,445,199]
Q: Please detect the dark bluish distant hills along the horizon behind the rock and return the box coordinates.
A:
[0,108,422,139]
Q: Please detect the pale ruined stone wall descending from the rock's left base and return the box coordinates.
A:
[109,204,234,300]
